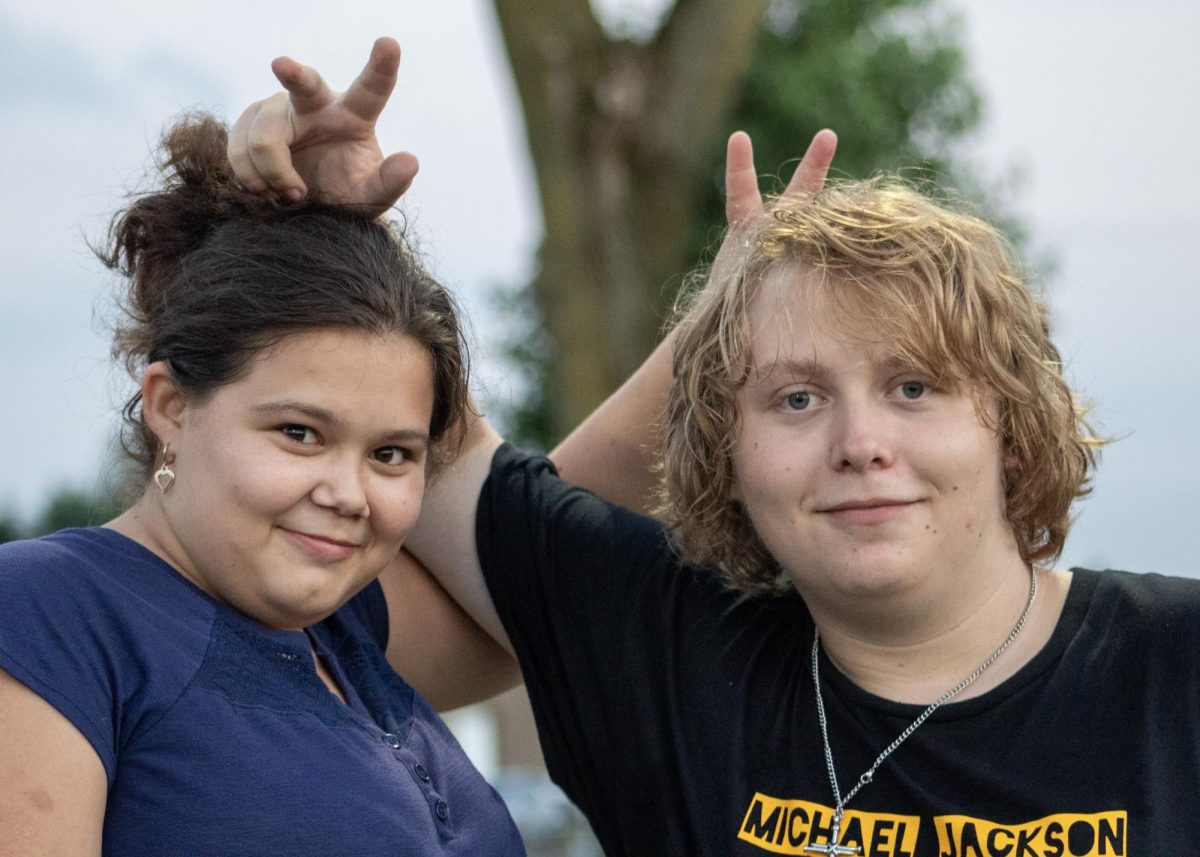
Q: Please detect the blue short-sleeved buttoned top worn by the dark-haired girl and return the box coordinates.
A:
[0,528,524,857]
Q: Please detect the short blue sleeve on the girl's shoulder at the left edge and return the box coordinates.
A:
[0,531,210,783]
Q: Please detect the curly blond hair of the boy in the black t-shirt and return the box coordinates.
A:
[660,176,1102,594]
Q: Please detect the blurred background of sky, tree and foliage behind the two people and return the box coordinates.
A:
[0,0,1200,855]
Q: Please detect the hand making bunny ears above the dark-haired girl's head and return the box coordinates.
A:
[229,38,418,214]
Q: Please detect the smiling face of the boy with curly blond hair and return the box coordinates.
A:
[734,266,1016,606]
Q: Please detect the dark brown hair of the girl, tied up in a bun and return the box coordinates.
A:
[96,114,467,469]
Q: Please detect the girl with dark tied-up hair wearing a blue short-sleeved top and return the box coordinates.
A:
[0,110,523,856]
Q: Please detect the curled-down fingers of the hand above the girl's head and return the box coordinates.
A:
[228,92,308,199]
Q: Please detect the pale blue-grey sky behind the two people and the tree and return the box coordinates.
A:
[0,0,1200,576]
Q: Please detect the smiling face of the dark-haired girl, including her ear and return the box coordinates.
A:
[148,330,433,628]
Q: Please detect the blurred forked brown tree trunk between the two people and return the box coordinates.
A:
[494,0,767,437]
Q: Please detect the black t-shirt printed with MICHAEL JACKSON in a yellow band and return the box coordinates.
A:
[478,447,1200,857]
